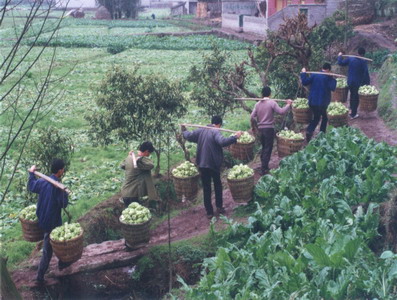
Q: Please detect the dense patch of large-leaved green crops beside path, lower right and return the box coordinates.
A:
[181,128,397,299]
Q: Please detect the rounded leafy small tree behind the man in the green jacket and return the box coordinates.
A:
[86,67,187,175]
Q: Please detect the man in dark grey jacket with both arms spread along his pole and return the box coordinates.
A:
[181,116,242,219]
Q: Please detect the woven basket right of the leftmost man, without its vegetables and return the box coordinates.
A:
[50,230,84,263]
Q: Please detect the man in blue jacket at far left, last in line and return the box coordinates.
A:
[28,158,70,284]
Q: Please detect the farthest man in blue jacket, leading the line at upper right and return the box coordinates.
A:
[338,47,370,120]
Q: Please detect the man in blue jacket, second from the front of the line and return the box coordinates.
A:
[301,63,336,142]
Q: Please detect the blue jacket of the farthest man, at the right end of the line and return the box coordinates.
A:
[338,56,370,87]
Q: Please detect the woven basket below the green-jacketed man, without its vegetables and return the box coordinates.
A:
[119,217,152,249]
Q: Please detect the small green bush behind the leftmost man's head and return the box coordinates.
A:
[27,126,74,174]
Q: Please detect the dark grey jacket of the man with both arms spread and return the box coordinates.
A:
[183,125,237,172]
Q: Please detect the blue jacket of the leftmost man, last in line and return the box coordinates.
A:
[28,173,68,232]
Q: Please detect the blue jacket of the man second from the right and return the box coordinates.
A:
[301,73,336,107]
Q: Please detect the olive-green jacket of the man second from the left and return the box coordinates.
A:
[120,155,159,200]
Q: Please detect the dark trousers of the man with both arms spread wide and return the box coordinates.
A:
[200,168,223,215]
